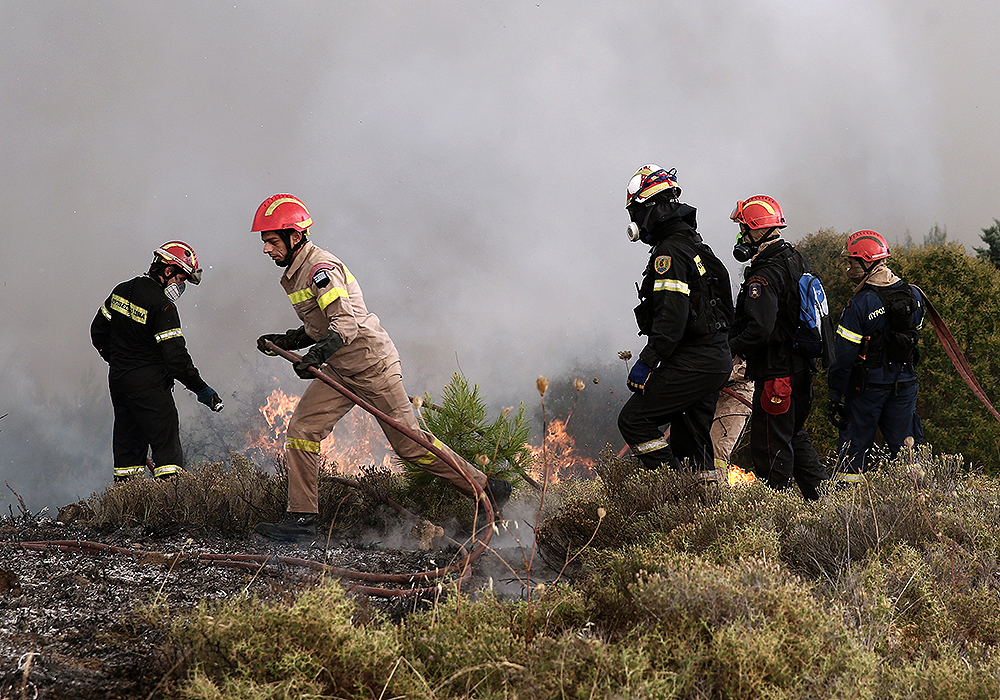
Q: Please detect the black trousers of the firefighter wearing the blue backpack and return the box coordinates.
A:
[750,369,827,501]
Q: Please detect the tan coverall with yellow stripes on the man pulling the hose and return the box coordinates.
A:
[281,241,486,513]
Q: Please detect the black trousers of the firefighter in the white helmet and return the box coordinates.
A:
[618,367,730,471]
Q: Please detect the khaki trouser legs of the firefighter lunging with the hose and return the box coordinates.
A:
[285,357,486,513]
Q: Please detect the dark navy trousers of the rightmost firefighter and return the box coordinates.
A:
[837,379,923,474]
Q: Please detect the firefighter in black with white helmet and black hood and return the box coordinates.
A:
[618,165,733,481]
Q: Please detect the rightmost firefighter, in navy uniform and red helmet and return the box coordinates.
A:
[828,231,924,483]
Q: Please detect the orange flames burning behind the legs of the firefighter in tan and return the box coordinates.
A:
[247,389,395,475]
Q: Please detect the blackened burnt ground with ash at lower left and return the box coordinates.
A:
[0,517,546,700]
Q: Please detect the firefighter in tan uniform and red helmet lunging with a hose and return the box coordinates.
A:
[253,194,511,541]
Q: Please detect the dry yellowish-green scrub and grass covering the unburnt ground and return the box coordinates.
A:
[78,450,1000,700]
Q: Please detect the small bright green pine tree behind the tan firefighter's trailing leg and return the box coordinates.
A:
[406,372,532,484]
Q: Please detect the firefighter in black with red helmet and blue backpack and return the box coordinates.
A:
[730,195,827,500]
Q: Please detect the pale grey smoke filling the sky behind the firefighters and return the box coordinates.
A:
[0,0,1000,510]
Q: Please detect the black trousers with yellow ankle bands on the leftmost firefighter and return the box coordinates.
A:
[108,375,184,477]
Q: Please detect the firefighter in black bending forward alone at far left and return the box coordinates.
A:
[90,241,223,481]
